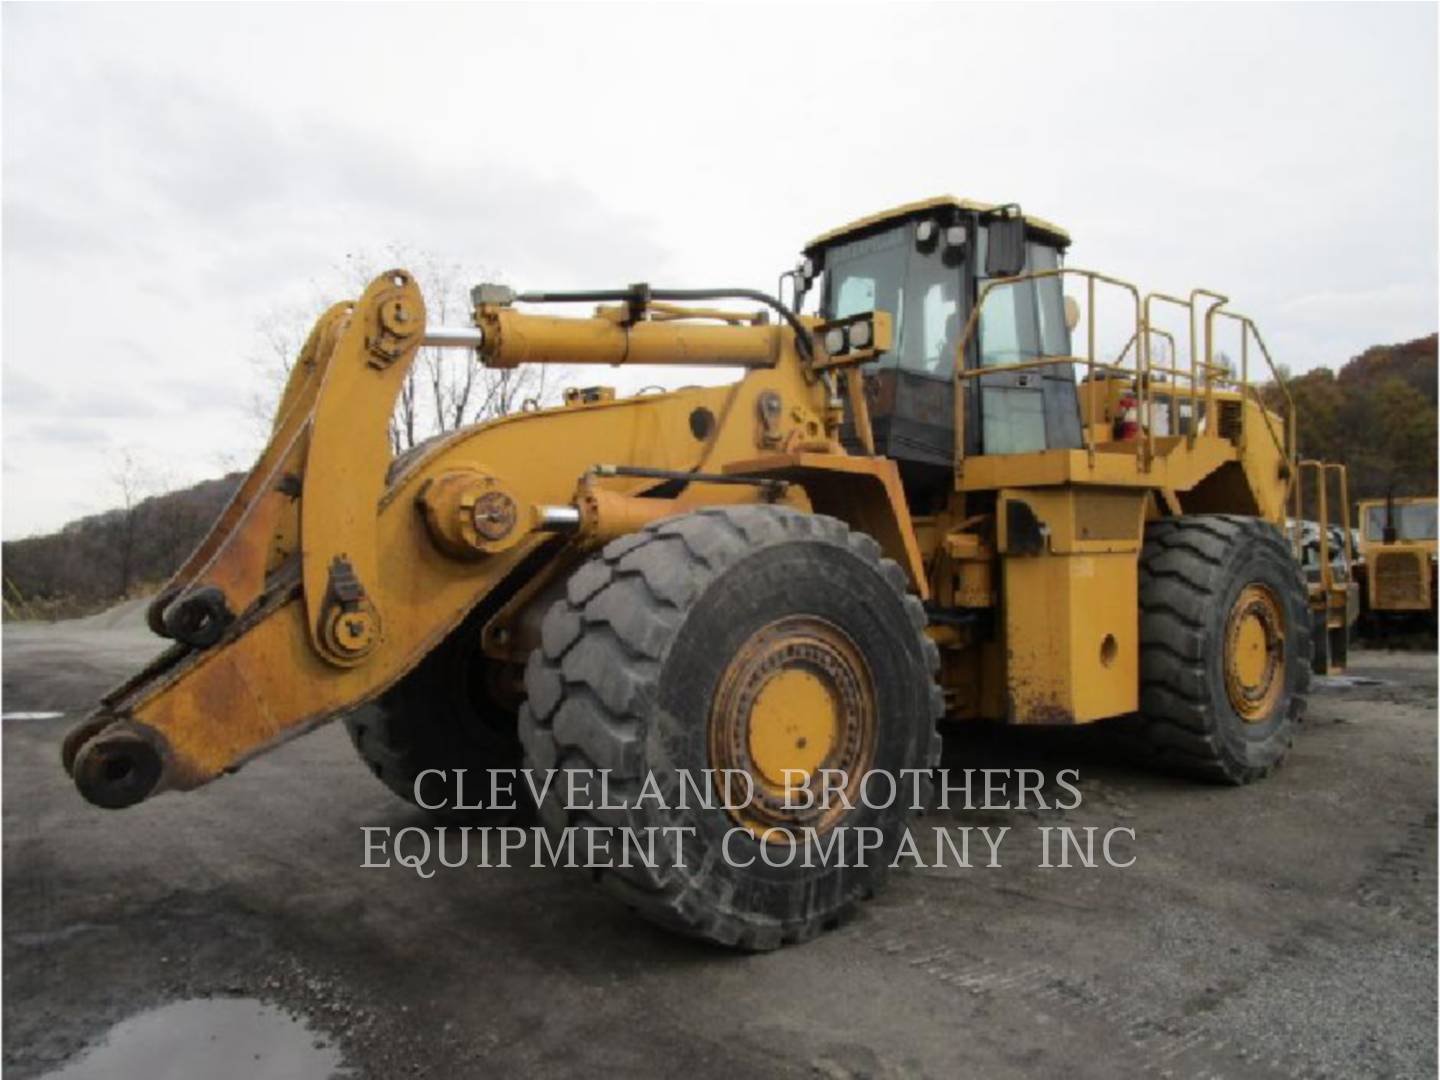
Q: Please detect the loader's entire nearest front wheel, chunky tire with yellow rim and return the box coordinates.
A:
[520,505,943,949]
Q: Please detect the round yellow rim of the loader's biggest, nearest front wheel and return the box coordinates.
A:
[710,615,876,840]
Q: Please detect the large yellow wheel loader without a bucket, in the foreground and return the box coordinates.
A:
[63,197,1344,949]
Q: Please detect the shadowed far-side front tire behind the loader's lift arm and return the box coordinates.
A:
[344,619,524,825]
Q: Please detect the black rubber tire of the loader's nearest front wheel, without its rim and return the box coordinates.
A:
[520,505,943,949]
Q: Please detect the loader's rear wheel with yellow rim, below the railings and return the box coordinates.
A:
[1139,514,1312,783]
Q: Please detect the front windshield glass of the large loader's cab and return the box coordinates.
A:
[824,223,962,379]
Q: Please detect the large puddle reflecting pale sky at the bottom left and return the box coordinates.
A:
[42,998,350,1080]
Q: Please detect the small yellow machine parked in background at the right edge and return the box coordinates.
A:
[1355,495,1436,622]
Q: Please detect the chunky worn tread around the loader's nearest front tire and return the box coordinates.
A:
[518,505,945,950]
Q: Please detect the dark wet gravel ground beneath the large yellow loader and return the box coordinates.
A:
[0,613,1436,1080]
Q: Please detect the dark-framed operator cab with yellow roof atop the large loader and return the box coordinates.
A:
[796,197,1081,505]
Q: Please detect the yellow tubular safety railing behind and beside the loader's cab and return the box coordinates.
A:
[955,266,1296,478]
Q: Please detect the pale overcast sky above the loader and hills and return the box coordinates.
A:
[0,4,1437,537]
